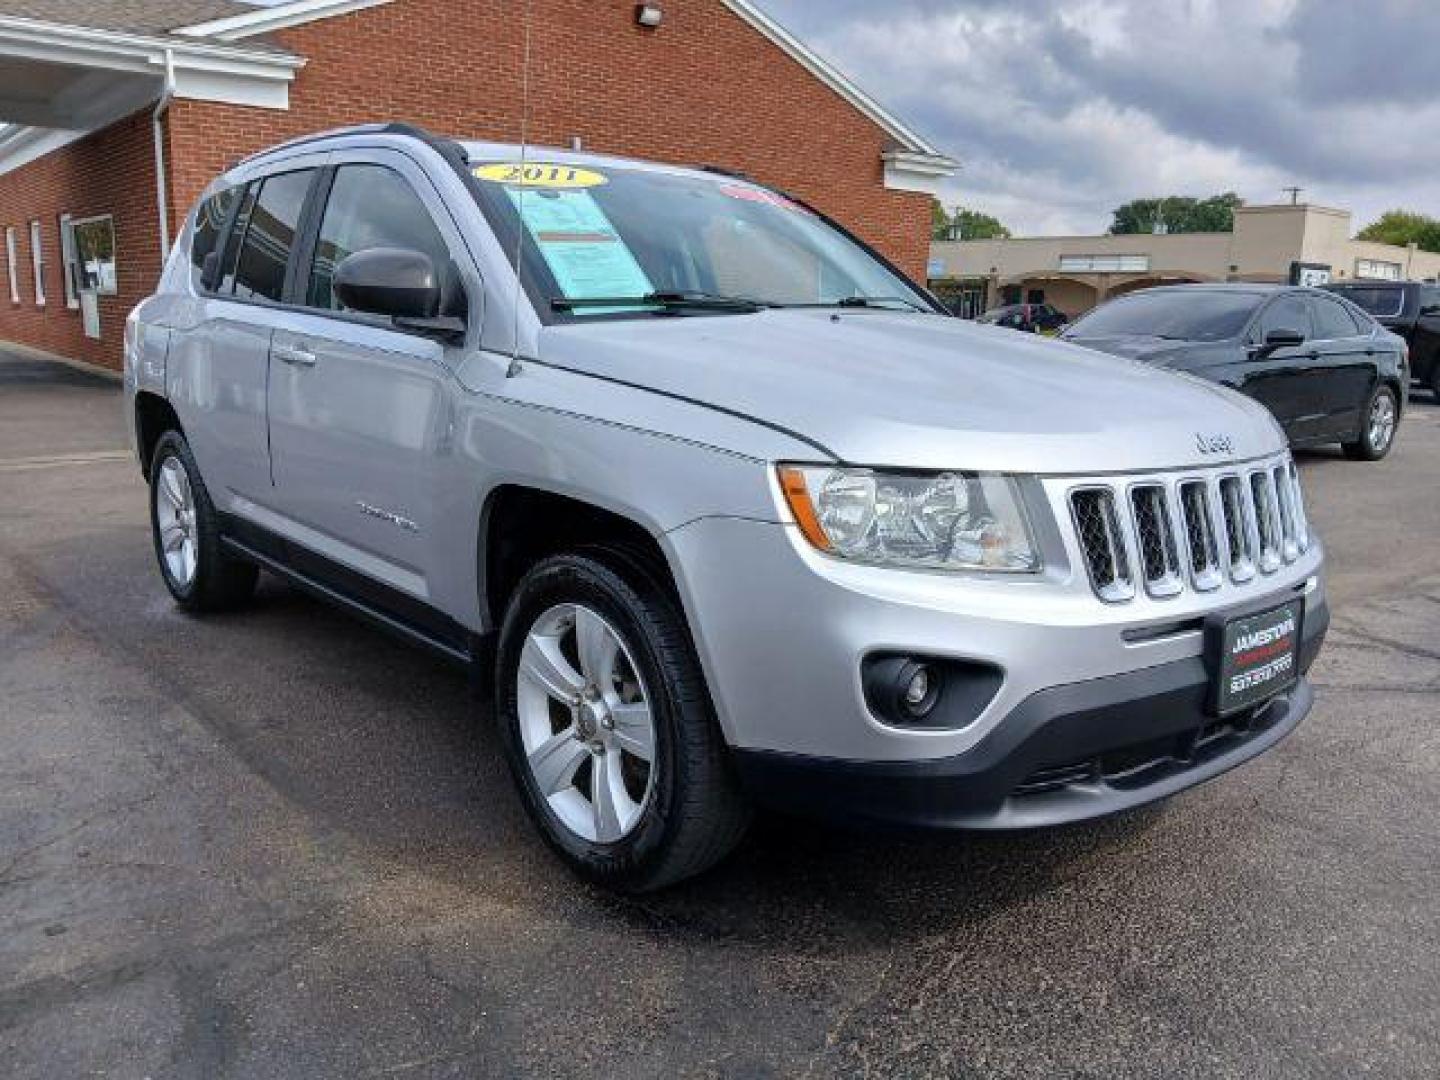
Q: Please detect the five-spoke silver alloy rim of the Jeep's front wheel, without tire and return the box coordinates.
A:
[516,603,657,844]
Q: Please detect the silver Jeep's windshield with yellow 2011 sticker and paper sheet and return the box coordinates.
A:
[460,161,933,320]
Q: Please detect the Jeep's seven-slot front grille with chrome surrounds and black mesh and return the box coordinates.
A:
[1068,456,1310,603]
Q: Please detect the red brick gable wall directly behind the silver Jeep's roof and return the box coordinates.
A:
[173,0,930,281]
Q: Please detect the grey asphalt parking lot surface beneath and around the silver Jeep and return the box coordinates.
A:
[8,350,1440,1079]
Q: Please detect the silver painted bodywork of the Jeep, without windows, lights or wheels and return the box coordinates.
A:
[127,132,1323,760]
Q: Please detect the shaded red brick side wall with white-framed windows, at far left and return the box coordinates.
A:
[0,111,160,367]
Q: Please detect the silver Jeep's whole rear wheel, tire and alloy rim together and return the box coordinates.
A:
[150,431,259,612]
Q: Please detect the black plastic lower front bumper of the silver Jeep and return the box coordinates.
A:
[736,600,1329,829]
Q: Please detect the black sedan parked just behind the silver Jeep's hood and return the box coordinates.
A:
[1061,284,1410,461]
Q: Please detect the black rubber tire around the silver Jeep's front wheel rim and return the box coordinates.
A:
[495,550,750,893]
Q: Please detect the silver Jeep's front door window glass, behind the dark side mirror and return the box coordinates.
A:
[305,166,451,311]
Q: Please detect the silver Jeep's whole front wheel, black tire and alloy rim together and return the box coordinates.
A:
[495,553,749,893]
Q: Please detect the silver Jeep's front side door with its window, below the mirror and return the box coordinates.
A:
[269,150,468,613]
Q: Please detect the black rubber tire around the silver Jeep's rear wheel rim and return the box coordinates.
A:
[150,431,259,612]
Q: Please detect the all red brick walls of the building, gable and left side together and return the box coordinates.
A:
[0,0,930,367]
